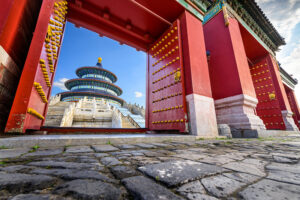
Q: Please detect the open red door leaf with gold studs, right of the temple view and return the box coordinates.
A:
[148,20,188,132]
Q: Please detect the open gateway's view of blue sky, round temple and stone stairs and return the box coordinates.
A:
[43,22,146,129]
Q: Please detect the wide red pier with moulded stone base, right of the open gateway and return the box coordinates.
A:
[204,12,265,129]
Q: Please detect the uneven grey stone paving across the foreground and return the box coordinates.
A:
[0,137,300,200]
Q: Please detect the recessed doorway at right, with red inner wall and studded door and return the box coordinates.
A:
[240,24,286,130]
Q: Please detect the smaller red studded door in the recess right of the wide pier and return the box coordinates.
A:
[250,59,285,130]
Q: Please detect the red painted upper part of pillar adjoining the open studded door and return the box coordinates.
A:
[180,11,212,97]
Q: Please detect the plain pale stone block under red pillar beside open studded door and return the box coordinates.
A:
[186,94,218,138]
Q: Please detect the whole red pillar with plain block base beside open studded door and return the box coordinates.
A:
[180,11,218,137]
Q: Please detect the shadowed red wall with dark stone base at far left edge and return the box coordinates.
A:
[0,0,42,132]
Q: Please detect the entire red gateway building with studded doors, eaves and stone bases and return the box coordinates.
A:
[0,0,299,137]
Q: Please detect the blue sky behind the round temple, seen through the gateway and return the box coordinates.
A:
[52,22,146,106]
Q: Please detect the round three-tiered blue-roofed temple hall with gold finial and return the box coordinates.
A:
[60,58,124,105]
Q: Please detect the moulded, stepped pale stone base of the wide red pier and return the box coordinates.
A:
[215,94,266,130]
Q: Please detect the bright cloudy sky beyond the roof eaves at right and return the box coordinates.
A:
[256,0,300,103]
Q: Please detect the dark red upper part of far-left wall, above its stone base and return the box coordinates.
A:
[0,0,42,69]
